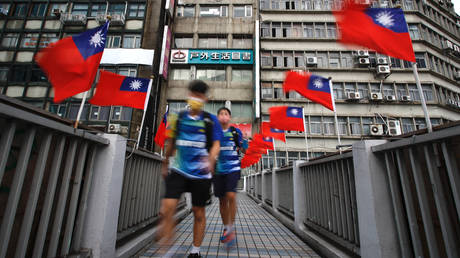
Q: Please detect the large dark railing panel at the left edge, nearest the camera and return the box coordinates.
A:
[0,97,108,258]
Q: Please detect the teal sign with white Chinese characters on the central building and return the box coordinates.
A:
[171,49,254,64]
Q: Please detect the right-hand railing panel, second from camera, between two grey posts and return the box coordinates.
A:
[300,152,359,254]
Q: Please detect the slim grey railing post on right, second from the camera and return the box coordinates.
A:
[292,160,307,230]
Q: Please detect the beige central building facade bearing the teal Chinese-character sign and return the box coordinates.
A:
[164,0,256,130]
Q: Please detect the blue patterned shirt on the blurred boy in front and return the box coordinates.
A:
[168,111,222,179]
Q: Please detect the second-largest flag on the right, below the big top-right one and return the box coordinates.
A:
[283,71,334,111]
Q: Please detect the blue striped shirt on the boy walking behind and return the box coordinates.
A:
[216,128,243,174]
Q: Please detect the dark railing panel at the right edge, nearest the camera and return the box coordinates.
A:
[372,125,460,257]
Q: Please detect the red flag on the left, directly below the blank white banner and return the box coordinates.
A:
[89,70,152,109]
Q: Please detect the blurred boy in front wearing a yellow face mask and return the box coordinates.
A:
[160,80,222,257]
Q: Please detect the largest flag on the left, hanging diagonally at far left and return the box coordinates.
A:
[35,22,109,102]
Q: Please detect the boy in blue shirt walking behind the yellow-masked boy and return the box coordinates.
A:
[213,107,243,248]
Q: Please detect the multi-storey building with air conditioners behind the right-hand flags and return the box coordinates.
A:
[260,0,460,167]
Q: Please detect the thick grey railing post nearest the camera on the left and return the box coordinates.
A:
[82,134,126,258]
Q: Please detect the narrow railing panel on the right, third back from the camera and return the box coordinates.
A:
[276,167,294,217]
